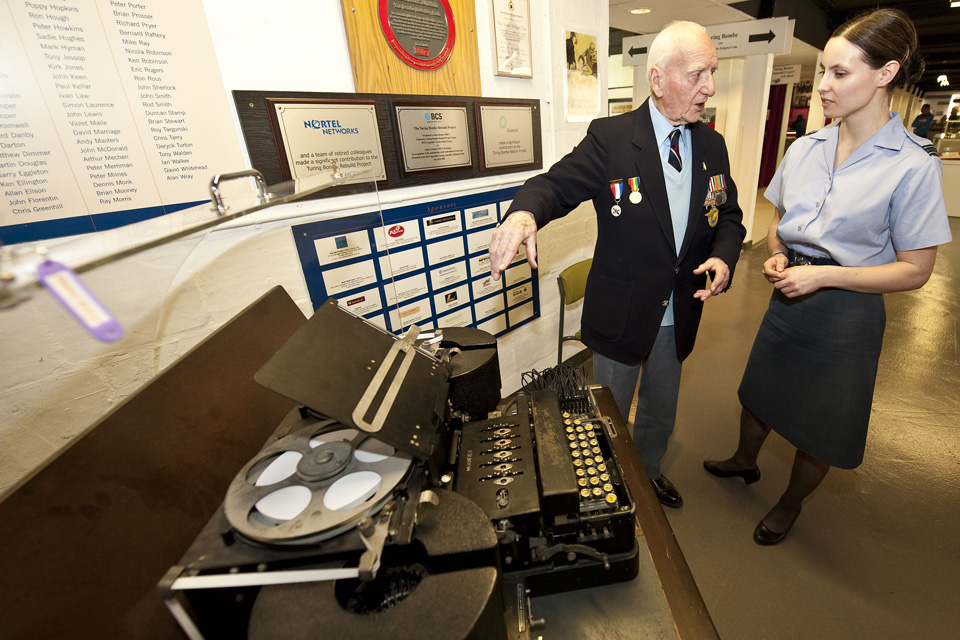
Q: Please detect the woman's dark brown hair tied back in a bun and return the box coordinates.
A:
[832,9,924,91]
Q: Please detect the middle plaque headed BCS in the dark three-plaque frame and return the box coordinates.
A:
[395,104,473,173]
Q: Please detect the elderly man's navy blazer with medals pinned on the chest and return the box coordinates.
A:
[508,99,746,364]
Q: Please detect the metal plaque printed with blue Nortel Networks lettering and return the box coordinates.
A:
[267,99,387,183]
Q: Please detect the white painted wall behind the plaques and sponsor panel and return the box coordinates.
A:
[0,0,608,497]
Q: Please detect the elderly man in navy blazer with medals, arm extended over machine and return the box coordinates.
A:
[490,22,745,507]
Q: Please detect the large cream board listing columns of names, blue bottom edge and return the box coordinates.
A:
[0,0,244,242]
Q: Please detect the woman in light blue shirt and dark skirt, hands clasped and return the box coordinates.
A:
[703,9,951,544]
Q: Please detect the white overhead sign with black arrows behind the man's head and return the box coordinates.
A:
[623,17,793,67]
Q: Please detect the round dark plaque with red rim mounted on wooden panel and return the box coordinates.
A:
[379,0,456,71]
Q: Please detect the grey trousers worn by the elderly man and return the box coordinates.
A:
[593,326,682,479]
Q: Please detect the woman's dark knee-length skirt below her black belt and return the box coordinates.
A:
[738,289,886,469]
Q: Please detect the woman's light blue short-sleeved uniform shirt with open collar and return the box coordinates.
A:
[764,112,951,267]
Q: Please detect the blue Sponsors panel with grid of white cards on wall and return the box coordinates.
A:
[292,185,540,335]
